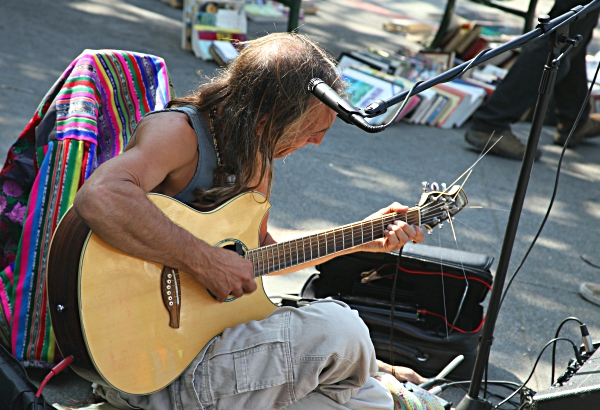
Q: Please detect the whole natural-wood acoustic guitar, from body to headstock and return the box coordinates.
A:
[46,185,467,394]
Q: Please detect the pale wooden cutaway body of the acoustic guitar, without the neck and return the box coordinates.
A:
[46,192,277,394]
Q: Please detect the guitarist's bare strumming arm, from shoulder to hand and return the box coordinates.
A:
[74,114,256,301]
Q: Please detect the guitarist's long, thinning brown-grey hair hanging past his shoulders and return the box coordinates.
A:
[169,33,345,208]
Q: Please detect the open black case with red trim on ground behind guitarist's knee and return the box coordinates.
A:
[301,244,493,380]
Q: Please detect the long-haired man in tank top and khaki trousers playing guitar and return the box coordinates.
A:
[74,34,424,409]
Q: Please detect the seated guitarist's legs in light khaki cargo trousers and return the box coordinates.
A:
[172,301,384,409]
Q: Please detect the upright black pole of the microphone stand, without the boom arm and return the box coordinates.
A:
[456,12,568,410]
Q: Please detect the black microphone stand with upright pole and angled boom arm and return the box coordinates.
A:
[310,0,600,410]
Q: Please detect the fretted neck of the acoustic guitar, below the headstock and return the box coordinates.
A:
[246,207,421,277]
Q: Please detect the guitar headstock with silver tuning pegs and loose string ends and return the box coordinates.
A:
[417,182,469,233]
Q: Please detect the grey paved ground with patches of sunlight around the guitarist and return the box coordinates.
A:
[0,0,600,403]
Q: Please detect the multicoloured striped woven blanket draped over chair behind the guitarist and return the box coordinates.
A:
[0,50,172,366]
